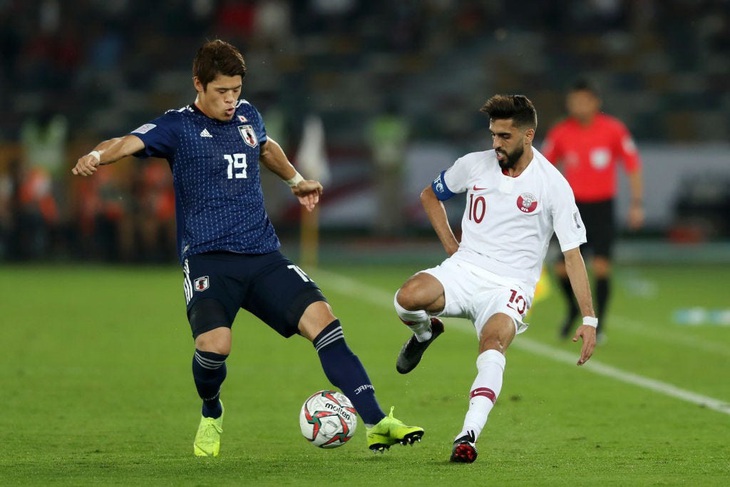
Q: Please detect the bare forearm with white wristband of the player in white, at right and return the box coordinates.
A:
[563,247,597,365]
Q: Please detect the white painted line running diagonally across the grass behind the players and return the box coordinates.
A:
[314,270,730,415]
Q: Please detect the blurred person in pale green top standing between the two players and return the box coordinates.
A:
[368,98,410,237]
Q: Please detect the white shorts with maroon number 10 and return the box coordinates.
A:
[421,257,533,336]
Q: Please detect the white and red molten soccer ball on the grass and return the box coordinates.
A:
[299,390,357,448]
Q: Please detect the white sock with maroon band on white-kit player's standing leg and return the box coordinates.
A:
[456,350,506,439]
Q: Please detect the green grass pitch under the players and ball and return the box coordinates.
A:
[0,265,730,486]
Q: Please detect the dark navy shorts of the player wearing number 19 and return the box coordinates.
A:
[183,251,327,337]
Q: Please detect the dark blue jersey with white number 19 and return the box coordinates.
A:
[131,100,280,262]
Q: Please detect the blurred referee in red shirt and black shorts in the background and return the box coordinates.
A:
[542,79,644,342]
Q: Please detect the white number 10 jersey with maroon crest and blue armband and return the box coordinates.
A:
[432,149,584,293]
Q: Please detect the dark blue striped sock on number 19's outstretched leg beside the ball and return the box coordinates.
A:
[312,320,385,425]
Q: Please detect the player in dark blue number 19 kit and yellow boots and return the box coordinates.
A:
[72,40,424,457]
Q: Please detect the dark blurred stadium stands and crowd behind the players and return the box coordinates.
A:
[0,0,730,262]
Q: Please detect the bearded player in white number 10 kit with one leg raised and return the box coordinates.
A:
[394,95,598,463]
